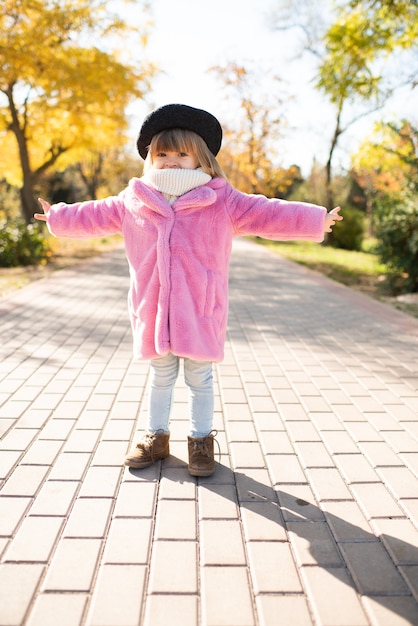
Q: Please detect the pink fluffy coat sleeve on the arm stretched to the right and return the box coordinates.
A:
[226,187,327,242]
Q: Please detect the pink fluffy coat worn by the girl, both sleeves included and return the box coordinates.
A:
[48,178,326,361]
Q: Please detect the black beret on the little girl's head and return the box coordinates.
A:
[136,104,222,159]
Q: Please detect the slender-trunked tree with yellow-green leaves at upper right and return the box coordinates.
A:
[270,0,418,208]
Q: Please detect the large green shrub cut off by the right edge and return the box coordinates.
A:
[376,198,418,292]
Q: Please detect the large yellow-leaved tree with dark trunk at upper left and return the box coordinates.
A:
[0,0,153,222]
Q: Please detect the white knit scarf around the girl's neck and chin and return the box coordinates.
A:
[142,168,212,204]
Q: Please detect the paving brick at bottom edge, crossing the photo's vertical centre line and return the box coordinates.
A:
[201,567,256,626]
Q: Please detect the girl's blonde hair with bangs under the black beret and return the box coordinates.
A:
[144,128,226,179]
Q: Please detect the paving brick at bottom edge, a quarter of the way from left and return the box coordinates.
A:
[87,565,146,626]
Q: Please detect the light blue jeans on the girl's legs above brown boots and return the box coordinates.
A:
[147,353,214,437]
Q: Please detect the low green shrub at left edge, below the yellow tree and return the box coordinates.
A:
[0,220,51,267]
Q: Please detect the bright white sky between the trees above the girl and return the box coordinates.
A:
[119,0,417,175]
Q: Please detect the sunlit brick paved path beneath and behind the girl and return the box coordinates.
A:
[0,241,418,626]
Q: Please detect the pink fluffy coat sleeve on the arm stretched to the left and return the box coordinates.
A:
[47,192,125,238]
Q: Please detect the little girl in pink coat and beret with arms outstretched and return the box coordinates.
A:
[35,104,343,476]
